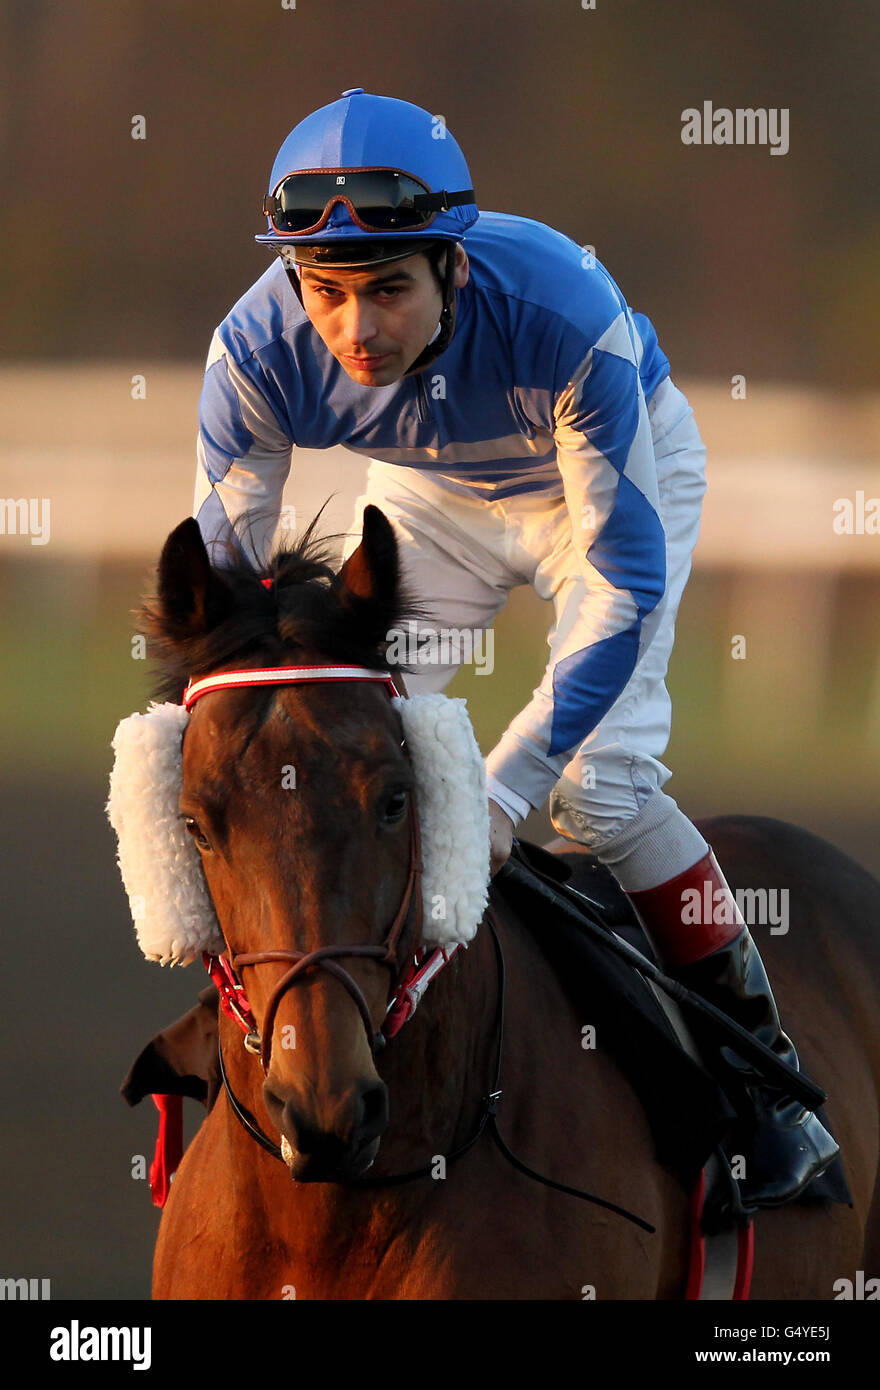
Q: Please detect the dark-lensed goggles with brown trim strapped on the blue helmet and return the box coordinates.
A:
[263,168,474,236]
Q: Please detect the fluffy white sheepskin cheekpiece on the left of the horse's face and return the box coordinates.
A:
[107,703,224,965]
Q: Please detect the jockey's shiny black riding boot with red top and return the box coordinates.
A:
[630,851,840,1208]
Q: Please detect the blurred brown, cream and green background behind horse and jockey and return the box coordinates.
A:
[0,0,880,1298]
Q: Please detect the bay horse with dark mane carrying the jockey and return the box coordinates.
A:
[123,507,880,1300]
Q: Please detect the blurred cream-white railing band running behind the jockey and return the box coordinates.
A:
[0,364,880,575]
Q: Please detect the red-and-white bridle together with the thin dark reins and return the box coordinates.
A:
[184,666,656,1233]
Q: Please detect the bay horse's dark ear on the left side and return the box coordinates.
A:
[158,517,232,642]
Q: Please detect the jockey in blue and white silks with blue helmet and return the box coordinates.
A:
[193,88,838,1208]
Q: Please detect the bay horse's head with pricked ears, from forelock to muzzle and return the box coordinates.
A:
[110,507,488,1182]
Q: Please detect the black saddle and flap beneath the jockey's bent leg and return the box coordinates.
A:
[494,840,852,1233]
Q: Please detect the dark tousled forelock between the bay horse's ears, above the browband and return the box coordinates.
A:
[136,503,427,703]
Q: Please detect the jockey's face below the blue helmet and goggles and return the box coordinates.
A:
[300,246,467,386]
